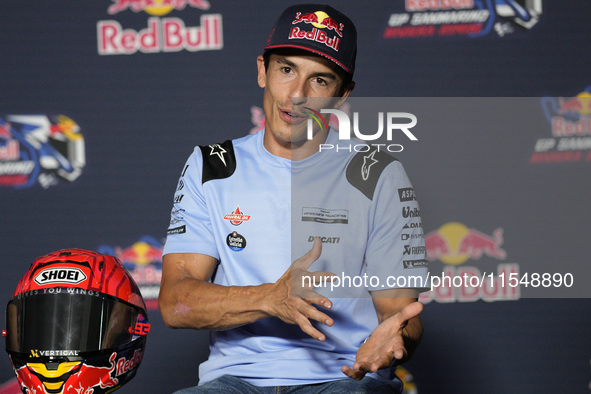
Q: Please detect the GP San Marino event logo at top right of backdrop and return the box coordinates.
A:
[383,0,542,39]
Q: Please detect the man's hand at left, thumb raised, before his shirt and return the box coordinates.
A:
[267,237,335,341]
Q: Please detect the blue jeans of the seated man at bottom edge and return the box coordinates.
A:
[174,375,400,394]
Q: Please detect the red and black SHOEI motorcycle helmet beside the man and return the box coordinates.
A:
[6,249,150,394]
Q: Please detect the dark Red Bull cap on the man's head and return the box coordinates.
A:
[264,4,357,75]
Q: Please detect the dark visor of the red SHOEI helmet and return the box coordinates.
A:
[6,288,141,357]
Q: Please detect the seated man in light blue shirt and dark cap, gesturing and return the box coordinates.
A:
[159,4,426,393]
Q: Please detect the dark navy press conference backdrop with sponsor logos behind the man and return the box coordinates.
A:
[0,0,591,394]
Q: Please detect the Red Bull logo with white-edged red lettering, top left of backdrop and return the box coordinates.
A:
[97,0,224,55]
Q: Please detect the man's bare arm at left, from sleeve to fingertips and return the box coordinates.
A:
[158,242,333,341]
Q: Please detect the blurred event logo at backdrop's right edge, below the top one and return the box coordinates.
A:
[530,86,591,164]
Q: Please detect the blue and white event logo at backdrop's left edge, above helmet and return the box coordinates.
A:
[0,115,86,189]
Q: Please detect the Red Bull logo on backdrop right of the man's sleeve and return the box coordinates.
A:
[421,222,520,302]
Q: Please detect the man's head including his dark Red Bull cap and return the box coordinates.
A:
[257,4,357,155]
